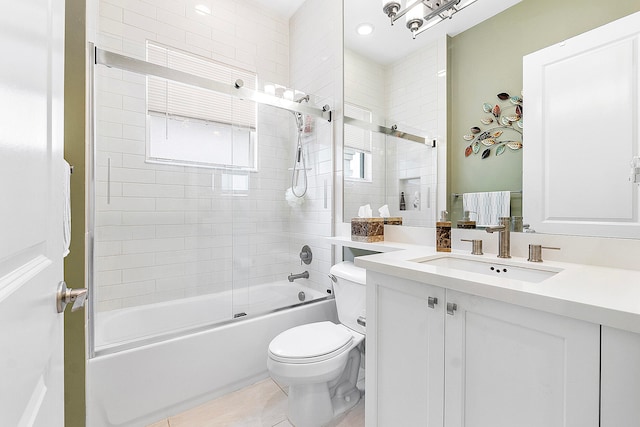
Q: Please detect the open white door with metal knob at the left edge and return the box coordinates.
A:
[0,0,64,427]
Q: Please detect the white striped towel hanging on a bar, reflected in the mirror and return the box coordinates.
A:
[462,191,511,227]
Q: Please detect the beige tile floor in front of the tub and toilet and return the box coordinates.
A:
[147,378,364,427]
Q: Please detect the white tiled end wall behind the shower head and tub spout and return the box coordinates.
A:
[289,0,343,291]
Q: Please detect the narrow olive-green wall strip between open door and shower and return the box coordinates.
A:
[64,0,87,427]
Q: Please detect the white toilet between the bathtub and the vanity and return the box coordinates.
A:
[267,261,366,427]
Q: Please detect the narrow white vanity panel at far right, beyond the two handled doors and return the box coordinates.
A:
[600,326,640,427]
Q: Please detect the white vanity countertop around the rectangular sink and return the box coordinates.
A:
[356,241,640,333]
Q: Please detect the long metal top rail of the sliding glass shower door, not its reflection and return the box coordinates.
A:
[95,47,332,122]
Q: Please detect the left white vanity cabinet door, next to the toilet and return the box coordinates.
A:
[365,272,444,427]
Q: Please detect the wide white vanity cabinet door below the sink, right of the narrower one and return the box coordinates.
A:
[445,290,600,427]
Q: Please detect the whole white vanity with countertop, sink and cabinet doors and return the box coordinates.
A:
[356,247,640,427]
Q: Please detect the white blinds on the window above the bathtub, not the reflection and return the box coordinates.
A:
[147,43,257,129]
